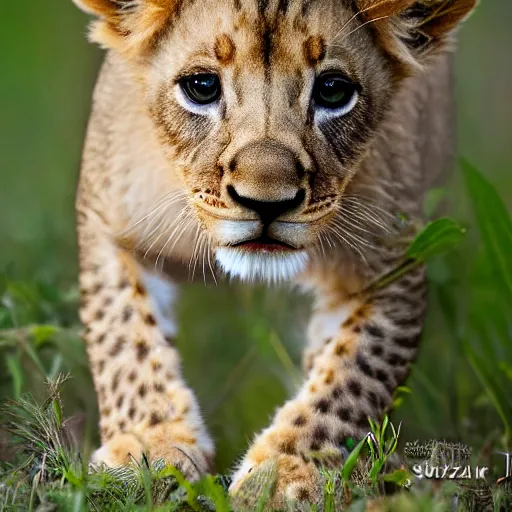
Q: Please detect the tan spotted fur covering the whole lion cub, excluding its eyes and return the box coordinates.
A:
[75,0,474,506]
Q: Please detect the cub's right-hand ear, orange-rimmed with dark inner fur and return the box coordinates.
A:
[356,0,478,67]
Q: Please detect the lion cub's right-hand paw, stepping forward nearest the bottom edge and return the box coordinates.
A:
[229,454,324,511]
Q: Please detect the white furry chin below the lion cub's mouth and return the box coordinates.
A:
[215,246,309,284]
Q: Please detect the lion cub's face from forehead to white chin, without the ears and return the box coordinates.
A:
[146,0,392,279]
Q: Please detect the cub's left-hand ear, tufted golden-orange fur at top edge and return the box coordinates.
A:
[73,0,176,55]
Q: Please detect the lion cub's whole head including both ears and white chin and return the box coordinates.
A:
[74,0,476,280]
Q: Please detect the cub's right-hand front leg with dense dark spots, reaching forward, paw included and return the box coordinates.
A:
[231,262,426,508]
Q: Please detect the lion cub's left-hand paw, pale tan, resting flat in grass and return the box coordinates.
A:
[91,434,213,481]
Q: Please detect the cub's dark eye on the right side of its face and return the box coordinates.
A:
[313,73,359,114]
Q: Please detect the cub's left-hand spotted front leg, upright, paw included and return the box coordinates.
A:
[78,200,214,479]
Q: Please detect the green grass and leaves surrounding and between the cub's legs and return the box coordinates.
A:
[0,162,512,512]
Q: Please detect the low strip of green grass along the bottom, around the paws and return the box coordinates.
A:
[0,377,512,512]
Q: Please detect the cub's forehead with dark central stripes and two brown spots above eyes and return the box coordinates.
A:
[154,0,354,72]
